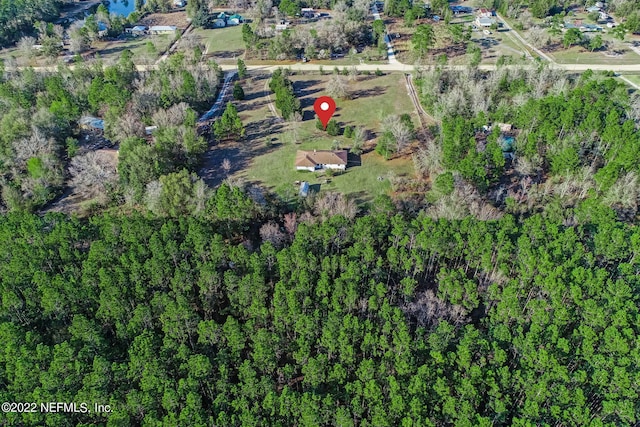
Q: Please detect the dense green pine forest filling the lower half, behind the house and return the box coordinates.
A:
[0,202,640,426]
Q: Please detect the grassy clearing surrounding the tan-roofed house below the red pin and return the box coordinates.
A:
[224,73,418,200]
